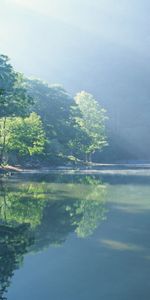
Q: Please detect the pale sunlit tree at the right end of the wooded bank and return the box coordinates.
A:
[75,91,107,160]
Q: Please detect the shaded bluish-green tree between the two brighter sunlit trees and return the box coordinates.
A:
[26,79,75,159]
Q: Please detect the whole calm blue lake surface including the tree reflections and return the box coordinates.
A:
[0,170,150,300]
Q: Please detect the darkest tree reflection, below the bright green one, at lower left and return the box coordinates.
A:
[0,224,33,300]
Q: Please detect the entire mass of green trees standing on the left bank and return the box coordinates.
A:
[0,55,107,165]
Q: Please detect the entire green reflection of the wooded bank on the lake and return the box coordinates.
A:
[0,175,107,299]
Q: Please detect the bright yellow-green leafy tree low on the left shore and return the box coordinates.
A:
[0,112,45,161]
